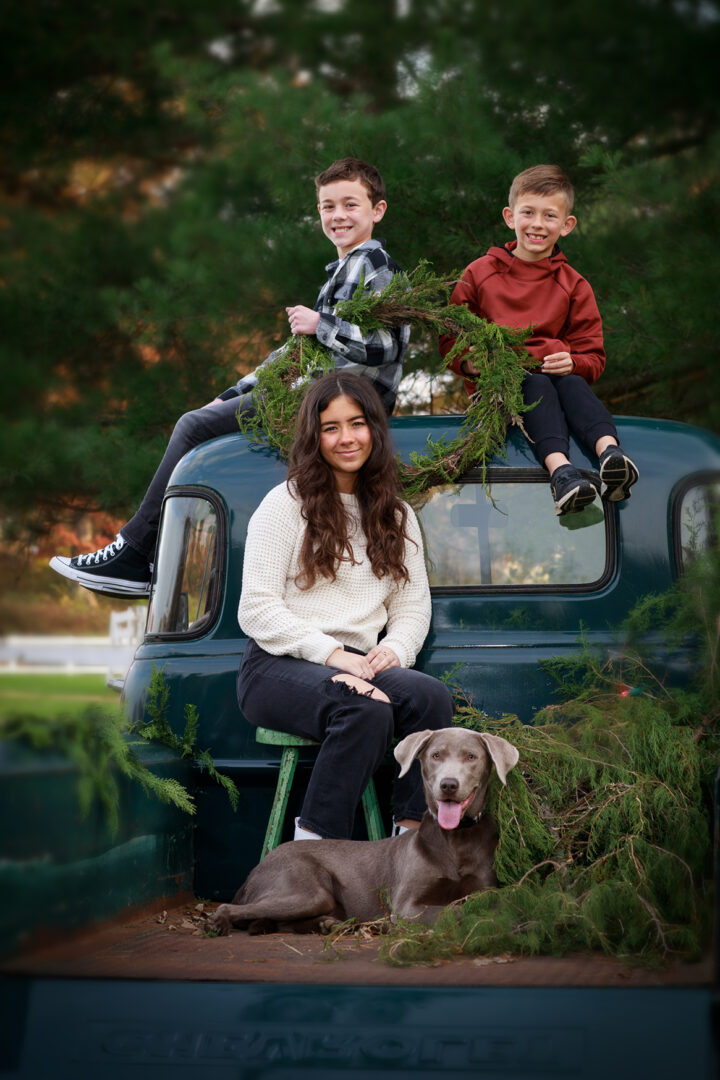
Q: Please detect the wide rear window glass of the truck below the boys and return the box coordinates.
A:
[419,482,608,588]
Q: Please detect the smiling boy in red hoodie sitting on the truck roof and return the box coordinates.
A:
[440,165,639,514]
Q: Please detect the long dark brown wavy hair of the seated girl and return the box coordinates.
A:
[287,372,409,589]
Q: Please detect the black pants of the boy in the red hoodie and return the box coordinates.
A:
[522,372,617,465]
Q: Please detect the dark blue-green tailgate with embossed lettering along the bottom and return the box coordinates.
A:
[0,978,719,1080]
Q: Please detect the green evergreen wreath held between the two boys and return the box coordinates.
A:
[239,262,536,502]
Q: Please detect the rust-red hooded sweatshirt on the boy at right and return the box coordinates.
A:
[439,240,604,394]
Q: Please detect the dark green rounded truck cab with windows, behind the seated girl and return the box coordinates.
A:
[124,417,720,899]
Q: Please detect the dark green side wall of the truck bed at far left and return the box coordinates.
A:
[0,742,194,955]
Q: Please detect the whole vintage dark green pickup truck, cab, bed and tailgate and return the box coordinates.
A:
[0,416,720,1080]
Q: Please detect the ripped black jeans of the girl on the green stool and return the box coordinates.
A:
[237,640,452,839]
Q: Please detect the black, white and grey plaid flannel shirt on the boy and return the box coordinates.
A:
[220,240,410,413]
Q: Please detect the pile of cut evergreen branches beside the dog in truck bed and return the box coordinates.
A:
[381,551,720,964]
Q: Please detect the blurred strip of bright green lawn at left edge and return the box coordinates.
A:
[0,673,120,723]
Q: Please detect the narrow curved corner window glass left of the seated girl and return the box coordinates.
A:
[147,495,218,634]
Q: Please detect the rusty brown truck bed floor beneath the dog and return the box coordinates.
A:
[0,897,714,987]
